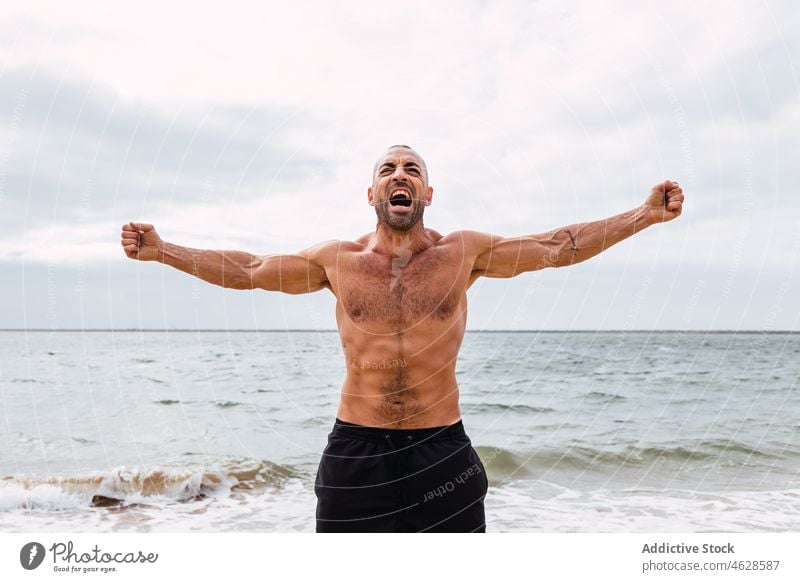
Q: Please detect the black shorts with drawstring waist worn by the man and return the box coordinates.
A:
[314,418,489,533]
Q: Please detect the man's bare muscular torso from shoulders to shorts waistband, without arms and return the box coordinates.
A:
[325,230,482,428]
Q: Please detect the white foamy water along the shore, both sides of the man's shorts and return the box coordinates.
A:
[6,478,800,533]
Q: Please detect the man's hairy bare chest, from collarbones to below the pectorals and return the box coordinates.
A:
[337,249,468,326]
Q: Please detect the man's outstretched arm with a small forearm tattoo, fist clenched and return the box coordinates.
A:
[472,180,684,280]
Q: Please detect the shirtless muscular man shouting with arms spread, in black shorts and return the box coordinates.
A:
[121,146,684,532]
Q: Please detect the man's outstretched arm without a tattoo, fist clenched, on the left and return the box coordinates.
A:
[121,222,328,294]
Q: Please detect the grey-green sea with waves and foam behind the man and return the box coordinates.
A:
[0,330,800,532]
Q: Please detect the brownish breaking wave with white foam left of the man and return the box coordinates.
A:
[0,460,298,511]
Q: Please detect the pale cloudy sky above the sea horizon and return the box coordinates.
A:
[0,0,800,330]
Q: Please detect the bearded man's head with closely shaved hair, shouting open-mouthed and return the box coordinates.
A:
[367,148,433,231]
